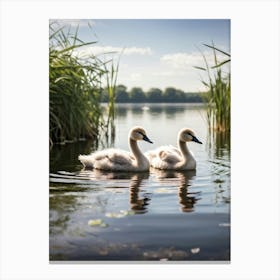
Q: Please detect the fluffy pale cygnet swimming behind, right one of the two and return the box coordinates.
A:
[145,128,202,170]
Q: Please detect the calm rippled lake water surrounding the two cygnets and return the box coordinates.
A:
[49,104,230,262]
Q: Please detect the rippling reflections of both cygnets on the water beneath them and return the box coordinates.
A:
[77,168,200,214]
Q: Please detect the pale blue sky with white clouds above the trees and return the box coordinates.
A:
[50,19,230,92]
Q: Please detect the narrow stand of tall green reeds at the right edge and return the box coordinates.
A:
[195,43,231,132]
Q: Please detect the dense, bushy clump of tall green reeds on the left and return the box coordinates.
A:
[49,23,116,144]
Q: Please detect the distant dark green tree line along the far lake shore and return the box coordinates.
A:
[101,85,202,103]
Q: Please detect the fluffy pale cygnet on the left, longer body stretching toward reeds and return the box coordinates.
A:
[79,126,153,172]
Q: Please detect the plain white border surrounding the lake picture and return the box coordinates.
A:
[0,0,280,280]
